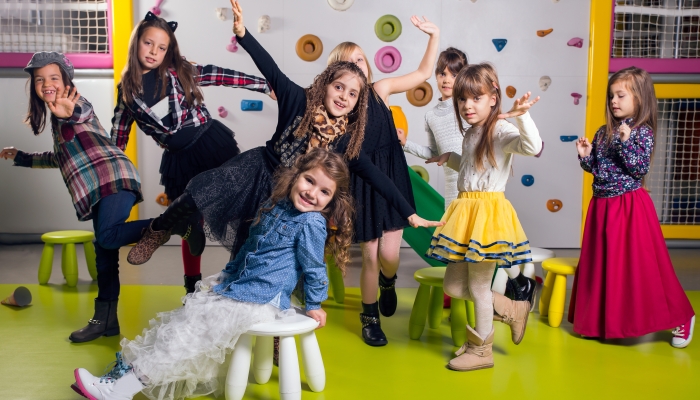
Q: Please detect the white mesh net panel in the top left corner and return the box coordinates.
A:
[0,0,109,54]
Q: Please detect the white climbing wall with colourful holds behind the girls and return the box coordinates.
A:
[134,0,590,247]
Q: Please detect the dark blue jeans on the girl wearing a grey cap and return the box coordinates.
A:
[92,190,151,301]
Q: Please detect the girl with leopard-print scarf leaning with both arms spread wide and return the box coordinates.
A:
[130,1,436,268]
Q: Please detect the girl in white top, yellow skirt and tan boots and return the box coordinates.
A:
[426,64,542,371]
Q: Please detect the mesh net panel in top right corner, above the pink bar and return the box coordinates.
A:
[610,0,700,58]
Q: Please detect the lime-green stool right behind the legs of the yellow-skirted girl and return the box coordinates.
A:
[408,267,474,346]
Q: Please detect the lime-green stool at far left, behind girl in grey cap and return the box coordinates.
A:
[39,231,97,287]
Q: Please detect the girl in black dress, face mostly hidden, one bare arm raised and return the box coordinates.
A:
[328,16,440,346]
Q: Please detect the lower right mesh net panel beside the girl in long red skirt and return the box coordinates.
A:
[646,99,700,225]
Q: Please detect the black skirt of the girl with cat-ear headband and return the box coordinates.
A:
[160,120,241,201]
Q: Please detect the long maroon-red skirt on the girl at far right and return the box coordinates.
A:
[569,189,694,338]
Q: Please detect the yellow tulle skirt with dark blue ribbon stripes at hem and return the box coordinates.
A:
[426,192,532,267]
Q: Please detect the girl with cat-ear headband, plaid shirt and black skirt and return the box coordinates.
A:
[112,11,270,293]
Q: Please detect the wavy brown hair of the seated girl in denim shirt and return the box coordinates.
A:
[255,148,355,274]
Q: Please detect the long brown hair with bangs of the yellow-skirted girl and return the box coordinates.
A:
[452,63,501,171]
